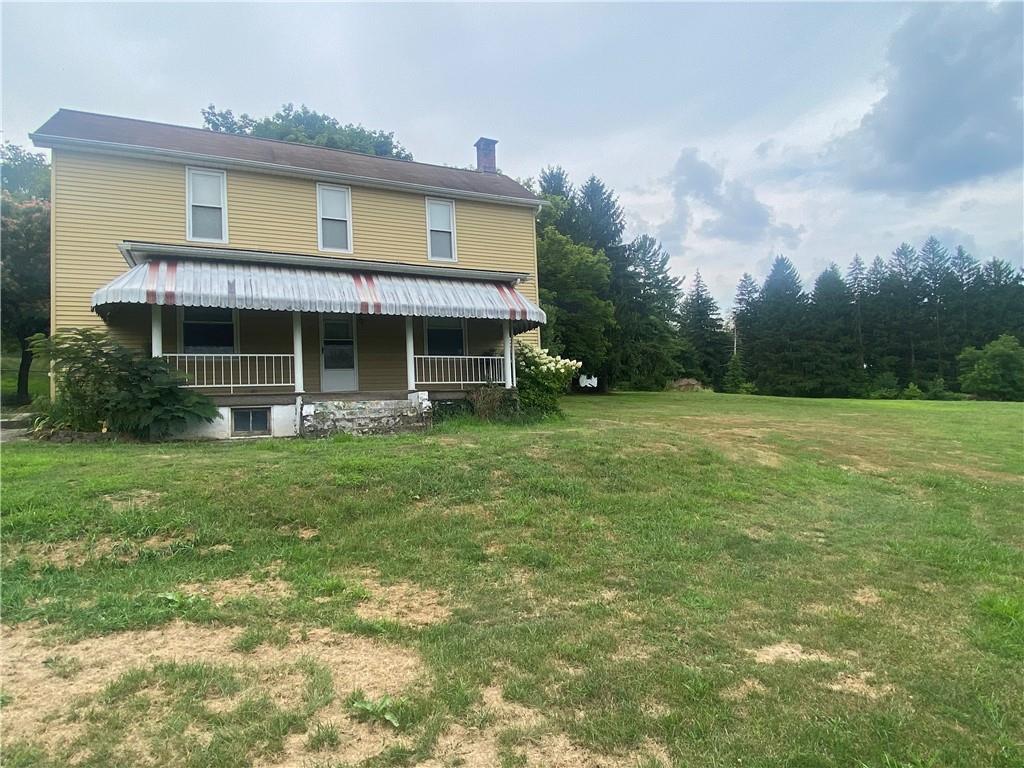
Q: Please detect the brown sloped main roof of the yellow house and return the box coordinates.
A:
[32,110,538,201]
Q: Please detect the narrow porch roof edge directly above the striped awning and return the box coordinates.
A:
[118,241,531,284]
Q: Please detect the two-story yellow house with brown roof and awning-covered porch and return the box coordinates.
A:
[32,110,545,436]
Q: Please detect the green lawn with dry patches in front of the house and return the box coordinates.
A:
[0,393,1024,768]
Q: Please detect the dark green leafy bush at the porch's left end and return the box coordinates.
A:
[33,329,218,439]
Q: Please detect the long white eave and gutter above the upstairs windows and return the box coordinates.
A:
[29,132,547,210]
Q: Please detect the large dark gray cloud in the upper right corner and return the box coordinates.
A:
[824,2,1024,194]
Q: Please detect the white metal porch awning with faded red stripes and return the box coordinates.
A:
[92,258,546,330]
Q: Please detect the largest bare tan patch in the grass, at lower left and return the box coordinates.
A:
[0,622,423,757]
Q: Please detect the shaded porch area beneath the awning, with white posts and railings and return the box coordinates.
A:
[150,305,515,399]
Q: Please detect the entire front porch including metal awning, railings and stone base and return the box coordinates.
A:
[92,244,545,436]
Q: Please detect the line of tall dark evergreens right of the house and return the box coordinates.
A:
[536,167,1024,397]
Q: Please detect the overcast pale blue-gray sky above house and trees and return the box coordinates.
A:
[2,2,1024,305]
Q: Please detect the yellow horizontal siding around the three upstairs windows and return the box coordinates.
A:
[52,150,538,343]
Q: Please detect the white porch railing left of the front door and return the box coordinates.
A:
[163,354,295,393]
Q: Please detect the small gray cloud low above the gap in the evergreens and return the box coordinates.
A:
[658,146,804,248]
